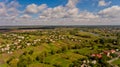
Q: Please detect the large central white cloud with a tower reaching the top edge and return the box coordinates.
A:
[39,0,99,19]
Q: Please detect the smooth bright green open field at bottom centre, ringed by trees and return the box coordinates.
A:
[44,52,85,67]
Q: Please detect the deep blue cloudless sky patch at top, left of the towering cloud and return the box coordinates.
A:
[18,0,67,10]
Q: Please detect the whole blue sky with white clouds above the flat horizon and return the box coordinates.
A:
[0,0,120,26]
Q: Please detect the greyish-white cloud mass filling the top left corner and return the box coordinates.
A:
[0,0,20,17]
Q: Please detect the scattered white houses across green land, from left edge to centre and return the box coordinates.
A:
[0,29,81,53]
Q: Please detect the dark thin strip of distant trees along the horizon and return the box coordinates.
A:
[0,25,120,30]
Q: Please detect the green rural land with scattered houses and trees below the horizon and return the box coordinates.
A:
[0,26,120,67]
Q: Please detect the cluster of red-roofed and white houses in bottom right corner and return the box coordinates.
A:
[81,49,120,67]
